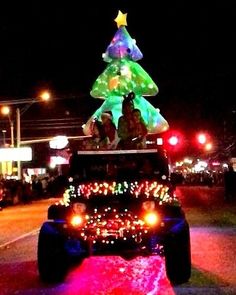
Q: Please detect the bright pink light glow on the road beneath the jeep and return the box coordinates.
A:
[58,256,175,295]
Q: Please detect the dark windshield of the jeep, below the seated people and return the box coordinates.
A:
[70,149,169,182]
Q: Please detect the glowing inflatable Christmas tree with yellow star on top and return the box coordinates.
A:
[83,11,169,135]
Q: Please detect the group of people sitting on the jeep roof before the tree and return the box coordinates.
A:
[83,92,148,149]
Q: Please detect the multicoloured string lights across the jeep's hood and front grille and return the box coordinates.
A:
[58,181,179,245]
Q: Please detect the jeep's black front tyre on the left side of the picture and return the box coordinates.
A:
[37,222,67,283]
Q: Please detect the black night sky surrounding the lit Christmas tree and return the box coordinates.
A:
[0,0,236,136]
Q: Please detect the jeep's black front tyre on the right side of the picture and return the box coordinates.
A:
[164,225,191,285]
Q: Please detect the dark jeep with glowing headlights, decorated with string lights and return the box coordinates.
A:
[37,148,191,284]
